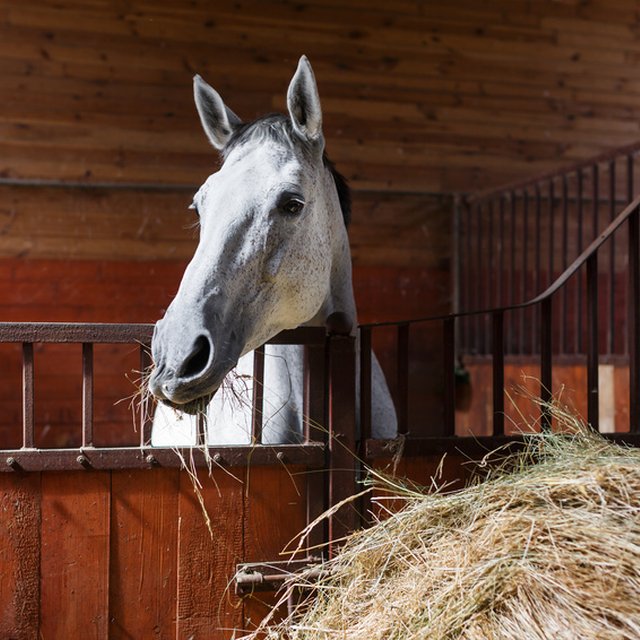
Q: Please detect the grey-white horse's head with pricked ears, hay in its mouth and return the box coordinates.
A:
[149,56,355,413]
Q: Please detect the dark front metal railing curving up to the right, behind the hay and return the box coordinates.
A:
[360,192,640,456]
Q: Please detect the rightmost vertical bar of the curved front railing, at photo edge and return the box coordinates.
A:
[627,208,640,433]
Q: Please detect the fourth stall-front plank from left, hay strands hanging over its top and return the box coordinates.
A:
[176,470,244,640]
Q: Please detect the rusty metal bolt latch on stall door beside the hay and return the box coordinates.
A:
[234,556,329,596]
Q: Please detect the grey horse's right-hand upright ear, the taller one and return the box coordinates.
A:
[287,56,322,142]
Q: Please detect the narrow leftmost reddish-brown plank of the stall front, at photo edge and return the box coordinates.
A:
[0,473,40,640]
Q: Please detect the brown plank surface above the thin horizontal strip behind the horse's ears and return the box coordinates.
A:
[0,0,640,194]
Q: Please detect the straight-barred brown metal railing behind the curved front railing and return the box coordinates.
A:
[455,143,640,356]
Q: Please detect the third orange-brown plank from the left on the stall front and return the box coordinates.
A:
[109,469,180,639]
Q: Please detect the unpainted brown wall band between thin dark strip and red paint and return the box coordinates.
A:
[0,182,451,268]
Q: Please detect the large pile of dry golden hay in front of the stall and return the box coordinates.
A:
[248,412,640,640]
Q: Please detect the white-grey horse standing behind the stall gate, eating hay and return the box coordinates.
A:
[148,56,397,446]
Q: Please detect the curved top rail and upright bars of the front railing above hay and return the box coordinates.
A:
[360,196,640,442]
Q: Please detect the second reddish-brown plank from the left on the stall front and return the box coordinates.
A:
[40,472,111,638]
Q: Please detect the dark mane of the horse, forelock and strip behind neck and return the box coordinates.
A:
[222,113,351,227]
